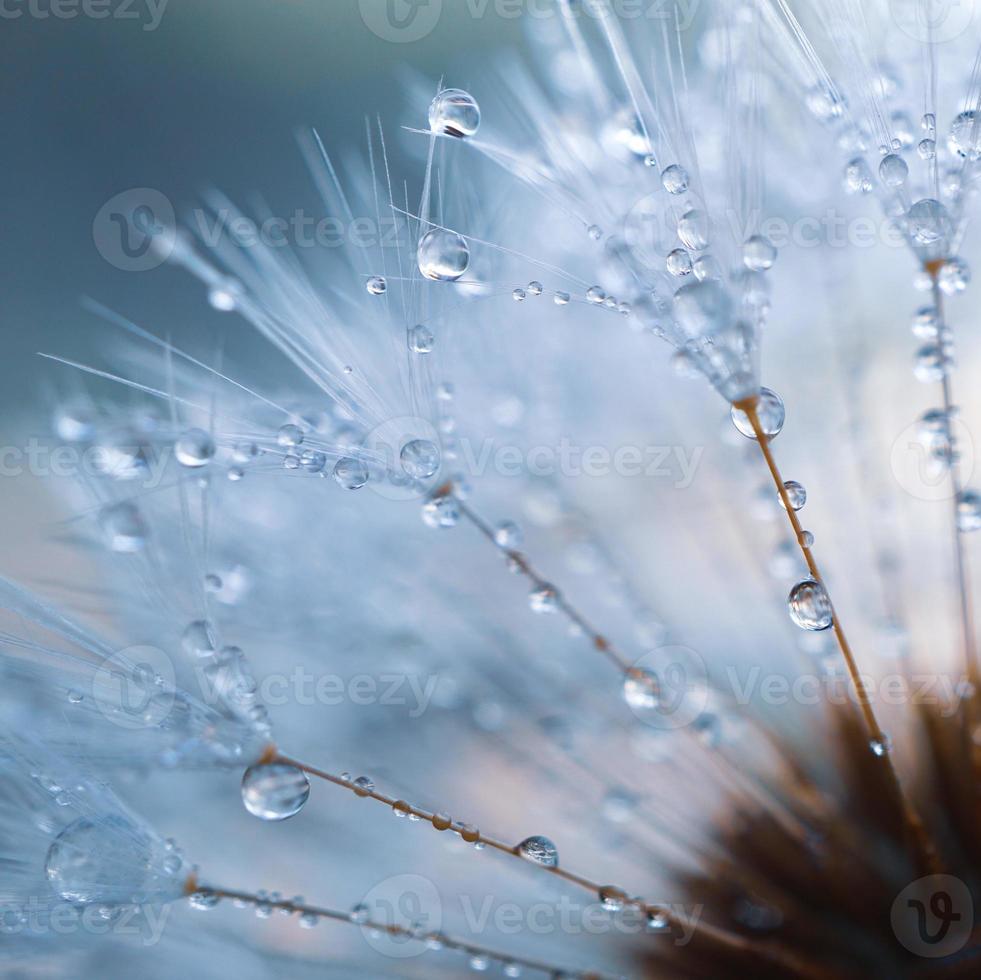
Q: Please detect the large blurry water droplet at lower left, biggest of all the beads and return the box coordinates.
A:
[44,814,153,905]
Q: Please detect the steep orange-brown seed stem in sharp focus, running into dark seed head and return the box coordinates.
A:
[734,396,939,872]
